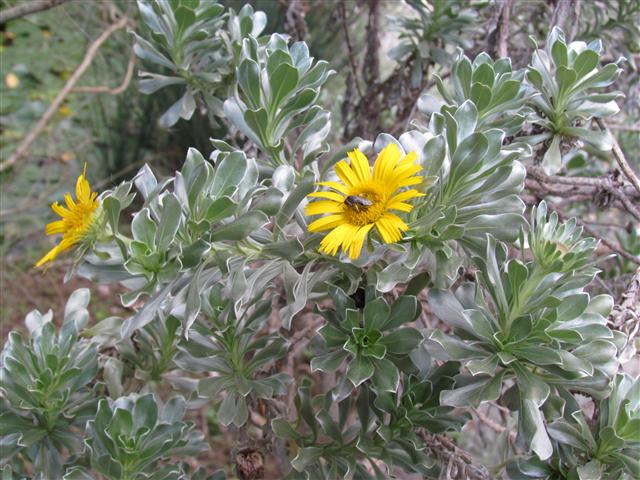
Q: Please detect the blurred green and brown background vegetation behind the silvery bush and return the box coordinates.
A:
[0,0,640,339]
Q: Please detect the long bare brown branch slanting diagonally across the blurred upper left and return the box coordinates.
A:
[0,16,129,172]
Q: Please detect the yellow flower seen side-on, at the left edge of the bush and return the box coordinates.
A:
[36,165,100,268]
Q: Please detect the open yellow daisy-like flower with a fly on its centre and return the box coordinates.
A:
[305,143,424,260]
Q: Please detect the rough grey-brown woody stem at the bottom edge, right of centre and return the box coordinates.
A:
[418,430,491,480]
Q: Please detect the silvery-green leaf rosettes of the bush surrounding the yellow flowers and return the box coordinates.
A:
[0,0,640,480]
